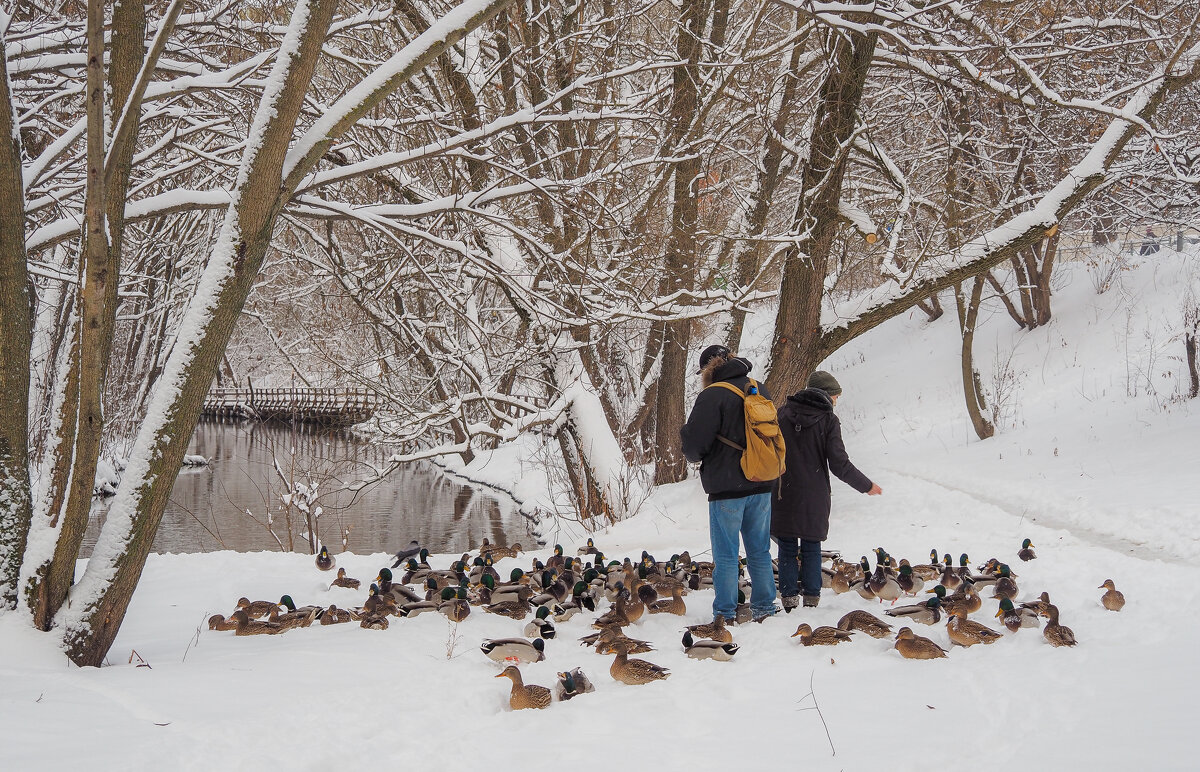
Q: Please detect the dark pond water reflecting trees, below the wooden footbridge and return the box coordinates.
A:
[82,421,532,557]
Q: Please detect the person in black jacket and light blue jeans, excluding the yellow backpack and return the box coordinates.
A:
[679,346,778,623]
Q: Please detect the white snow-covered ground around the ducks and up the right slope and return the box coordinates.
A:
[0,253,1200,771]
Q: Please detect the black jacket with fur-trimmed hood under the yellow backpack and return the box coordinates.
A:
[679,358,775,501]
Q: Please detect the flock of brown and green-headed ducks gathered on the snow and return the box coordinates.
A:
[209,539,1124,710]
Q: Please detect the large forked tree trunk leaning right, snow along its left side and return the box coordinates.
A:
[59,0,511,665]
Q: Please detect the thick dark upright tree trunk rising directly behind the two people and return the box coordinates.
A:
[767,30,878,402]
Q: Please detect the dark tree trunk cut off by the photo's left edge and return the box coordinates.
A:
[0,30,34,609]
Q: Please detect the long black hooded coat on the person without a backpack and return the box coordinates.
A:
[770,389,872,541]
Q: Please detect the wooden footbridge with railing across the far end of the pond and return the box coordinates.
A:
[202,389,383,426]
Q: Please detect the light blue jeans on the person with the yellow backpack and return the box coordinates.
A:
[708,493,775,620]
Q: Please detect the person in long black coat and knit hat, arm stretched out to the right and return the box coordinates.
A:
[770,370,883,614]
